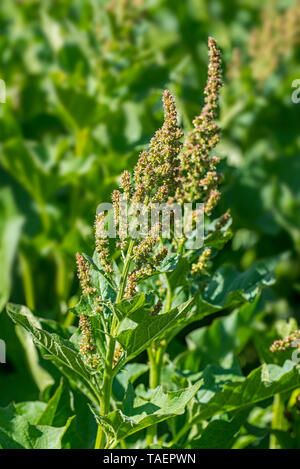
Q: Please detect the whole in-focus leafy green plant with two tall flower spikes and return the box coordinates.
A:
[0,38,300,448]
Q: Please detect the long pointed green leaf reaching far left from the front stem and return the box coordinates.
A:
[7,304,98,402]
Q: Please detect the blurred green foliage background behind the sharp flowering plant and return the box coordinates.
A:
[0,0,300,426]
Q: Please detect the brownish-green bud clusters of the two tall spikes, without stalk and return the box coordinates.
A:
[77,38,229,360]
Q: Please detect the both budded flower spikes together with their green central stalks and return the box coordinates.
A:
[77,38,229,447]
